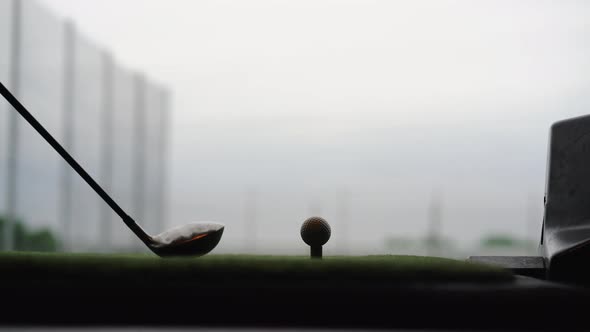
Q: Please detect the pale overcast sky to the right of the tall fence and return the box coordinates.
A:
[23,0,590,251]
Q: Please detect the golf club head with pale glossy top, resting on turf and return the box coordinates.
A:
[149,222,225,257]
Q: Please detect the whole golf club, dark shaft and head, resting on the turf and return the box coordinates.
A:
[0,82,225,257]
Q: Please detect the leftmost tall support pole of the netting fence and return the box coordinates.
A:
[4,0,22,250]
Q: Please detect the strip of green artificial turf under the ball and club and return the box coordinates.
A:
[0,252,513,285]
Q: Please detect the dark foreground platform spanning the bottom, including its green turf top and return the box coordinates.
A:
[0,253,590,330]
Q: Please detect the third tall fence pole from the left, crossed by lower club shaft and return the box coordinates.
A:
[99,52,114,249]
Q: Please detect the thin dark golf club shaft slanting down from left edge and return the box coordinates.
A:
[0,82,151,243]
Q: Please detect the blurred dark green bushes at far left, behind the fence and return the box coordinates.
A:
[0,216,60,251]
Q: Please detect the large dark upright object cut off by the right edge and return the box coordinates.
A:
[539,115,590,282]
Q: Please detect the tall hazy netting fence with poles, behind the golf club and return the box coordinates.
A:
[0,0,170,251]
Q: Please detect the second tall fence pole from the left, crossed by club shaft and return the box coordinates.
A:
[59,22,76,250]
